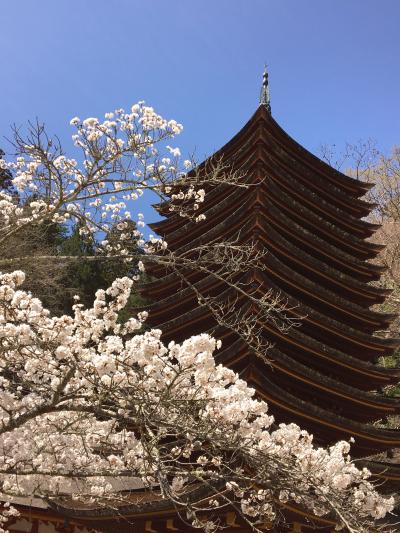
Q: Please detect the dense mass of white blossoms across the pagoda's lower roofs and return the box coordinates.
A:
[0,271,393,531]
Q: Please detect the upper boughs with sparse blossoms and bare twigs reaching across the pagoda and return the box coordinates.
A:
[0,102,299,357]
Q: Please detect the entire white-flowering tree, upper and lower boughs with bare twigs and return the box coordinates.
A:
[0,102,394,533]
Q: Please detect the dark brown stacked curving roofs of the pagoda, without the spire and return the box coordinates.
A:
[140,106,400,456]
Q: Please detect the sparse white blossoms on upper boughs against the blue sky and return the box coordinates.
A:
[0,102,204,261]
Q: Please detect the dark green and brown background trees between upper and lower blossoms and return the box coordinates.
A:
[0,149,148,319]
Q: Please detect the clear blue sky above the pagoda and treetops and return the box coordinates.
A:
[0,0,400,218]
